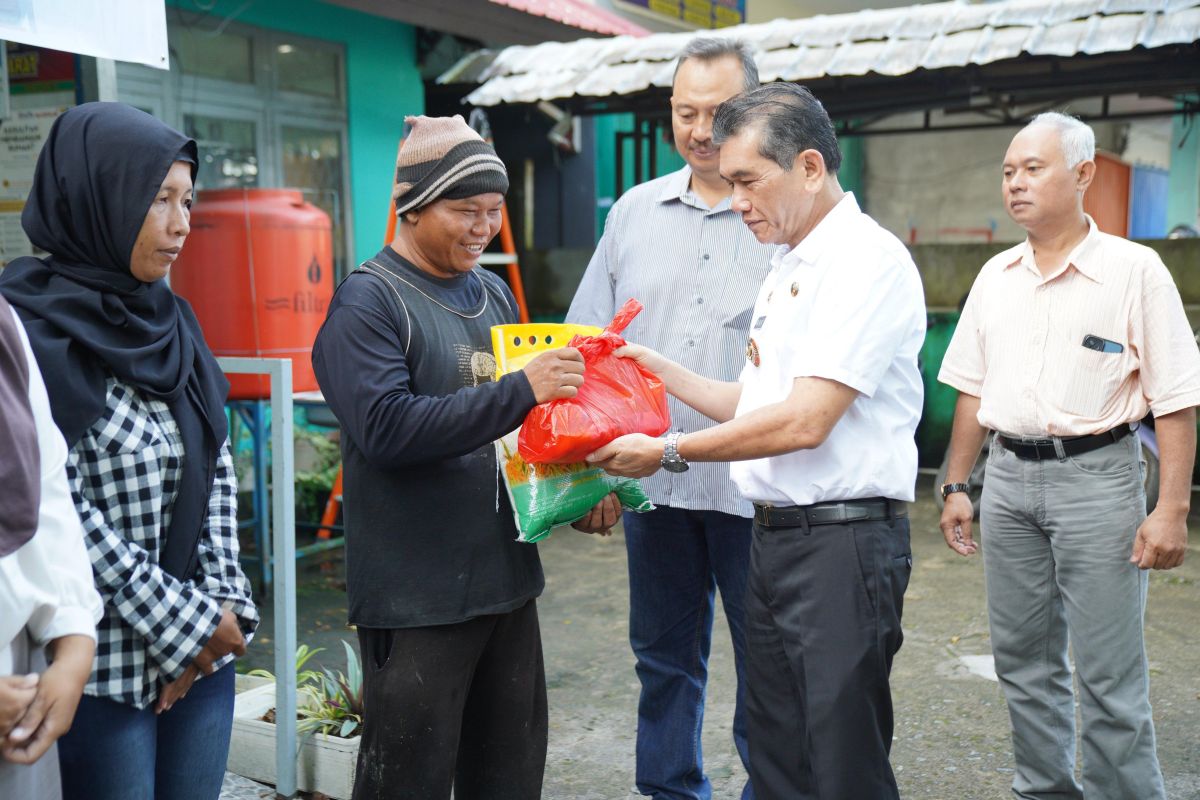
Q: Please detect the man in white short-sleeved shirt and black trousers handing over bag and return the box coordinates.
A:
[590,84,925,800]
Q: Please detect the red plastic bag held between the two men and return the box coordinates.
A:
[517,299,671,464]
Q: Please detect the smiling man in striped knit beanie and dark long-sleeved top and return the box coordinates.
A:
[312,116,590,800]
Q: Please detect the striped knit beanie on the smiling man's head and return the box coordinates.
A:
[391,114,509,215]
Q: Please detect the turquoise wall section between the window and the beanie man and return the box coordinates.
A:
[168,0,425,260]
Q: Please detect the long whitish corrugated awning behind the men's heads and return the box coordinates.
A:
[439,0,1200,131]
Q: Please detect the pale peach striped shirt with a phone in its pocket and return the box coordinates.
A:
[937,217,1200,437]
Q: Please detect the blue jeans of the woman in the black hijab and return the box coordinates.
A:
[59,663,234,800]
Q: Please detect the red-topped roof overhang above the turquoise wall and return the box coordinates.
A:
[325,0,648,44]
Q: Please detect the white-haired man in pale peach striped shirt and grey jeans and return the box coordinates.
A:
[938,114,1200,800]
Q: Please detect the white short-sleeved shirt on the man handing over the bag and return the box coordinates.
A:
[730,193,925,505]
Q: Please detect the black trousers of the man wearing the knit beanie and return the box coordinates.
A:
[354,600,548,800]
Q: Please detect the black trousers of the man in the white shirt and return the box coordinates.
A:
[745,518,912,800]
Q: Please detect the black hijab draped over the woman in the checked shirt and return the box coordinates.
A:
[0,103,229,579]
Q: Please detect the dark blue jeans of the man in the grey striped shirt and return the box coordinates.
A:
[624,506,754,800]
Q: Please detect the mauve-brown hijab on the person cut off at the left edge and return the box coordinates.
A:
[0,292,42,558]
